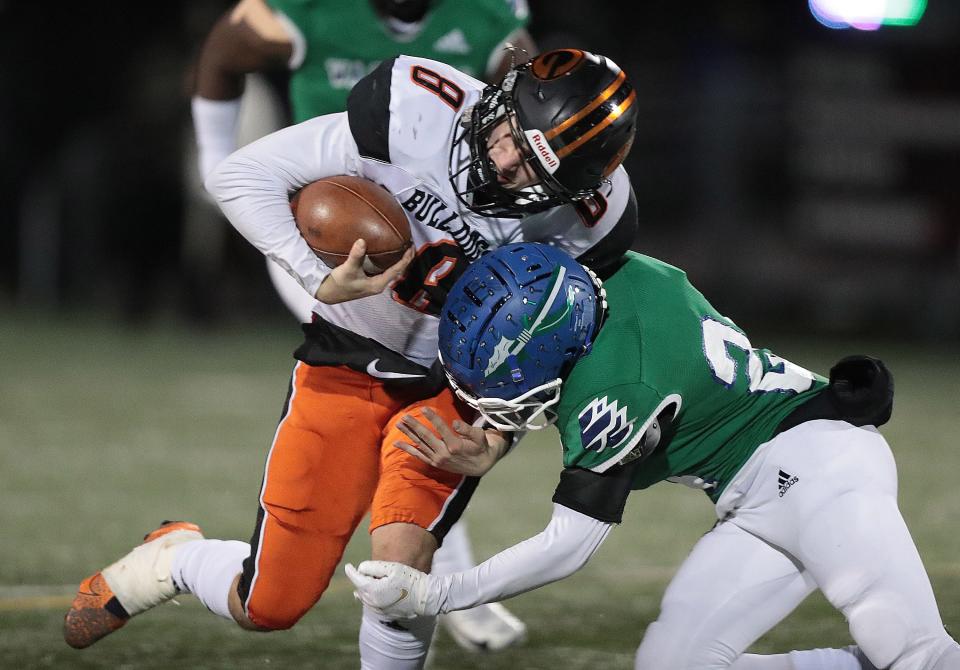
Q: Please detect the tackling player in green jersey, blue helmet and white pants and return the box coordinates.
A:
[347,243,960,670]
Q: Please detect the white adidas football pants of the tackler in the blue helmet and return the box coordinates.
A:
[636,420,957,670]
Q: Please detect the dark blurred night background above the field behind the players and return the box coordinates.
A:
[0,0,960,341]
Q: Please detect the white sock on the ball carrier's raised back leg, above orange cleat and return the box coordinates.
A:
[170,540,250,621]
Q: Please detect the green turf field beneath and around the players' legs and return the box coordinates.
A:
[0,313,960,670]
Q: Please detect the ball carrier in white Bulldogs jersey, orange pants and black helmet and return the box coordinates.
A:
[64,49,637,669]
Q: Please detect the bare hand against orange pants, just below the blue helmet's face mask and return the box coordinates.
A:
[393,407,509,477]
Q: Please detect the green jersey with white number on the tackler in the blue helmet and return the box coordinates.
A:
[557,252,826,501]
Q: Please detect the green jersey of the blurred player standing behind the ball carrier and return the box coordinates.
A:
[267,0,528,123]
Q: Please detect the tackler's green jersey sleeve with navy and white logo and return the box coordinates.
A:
[558,383,681,473]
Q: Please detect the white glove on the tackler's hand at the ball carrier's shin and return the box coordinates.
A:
[344,561,440,619]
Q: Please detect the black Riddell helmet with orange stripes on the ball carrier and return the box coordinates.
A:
[450,49,637,217]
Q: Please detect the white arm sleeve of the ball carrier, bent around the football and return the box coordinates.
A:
[205,113,359,295]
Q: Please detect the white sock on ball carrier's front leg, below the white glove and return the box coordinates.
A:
[360,607,437,670]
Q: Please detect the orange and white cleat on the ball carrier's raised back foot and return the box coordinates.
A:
[63,521,203,649]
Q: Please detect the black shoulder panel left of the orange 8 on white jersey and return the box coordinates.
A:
[347,58,397,163]
